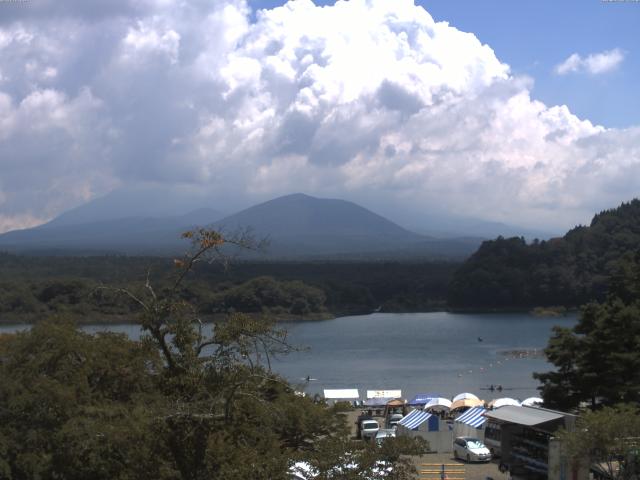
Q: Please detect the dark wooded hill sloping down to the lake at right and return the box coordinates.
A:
[449,199,640,308]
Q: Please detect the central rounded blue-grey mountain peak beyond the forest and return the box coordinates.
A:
[214,193,480,258]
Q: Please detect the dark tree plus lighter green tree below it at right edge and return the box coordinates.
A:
[534,250,640,480]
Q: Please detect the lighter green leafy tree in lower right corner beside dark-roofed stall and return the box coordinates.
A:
[559,405,640,480]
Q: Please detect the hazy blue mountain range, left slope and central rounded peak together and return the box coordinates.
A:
[0,193,480,260]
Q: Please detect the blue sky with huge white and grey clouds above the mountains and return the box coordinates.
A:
[0,0,640,232]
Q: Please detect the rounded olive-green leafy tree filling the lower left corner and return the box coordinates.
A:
[0,319,168,479]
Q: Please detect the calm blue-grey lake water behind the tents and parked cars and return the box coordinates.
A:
[0,312,577,400]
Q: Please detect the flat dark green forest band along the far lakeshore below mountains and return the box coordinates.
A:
[0,253,459,323]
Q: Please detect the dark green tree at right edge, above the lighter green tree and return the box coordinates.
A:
[534,251,640,409]
